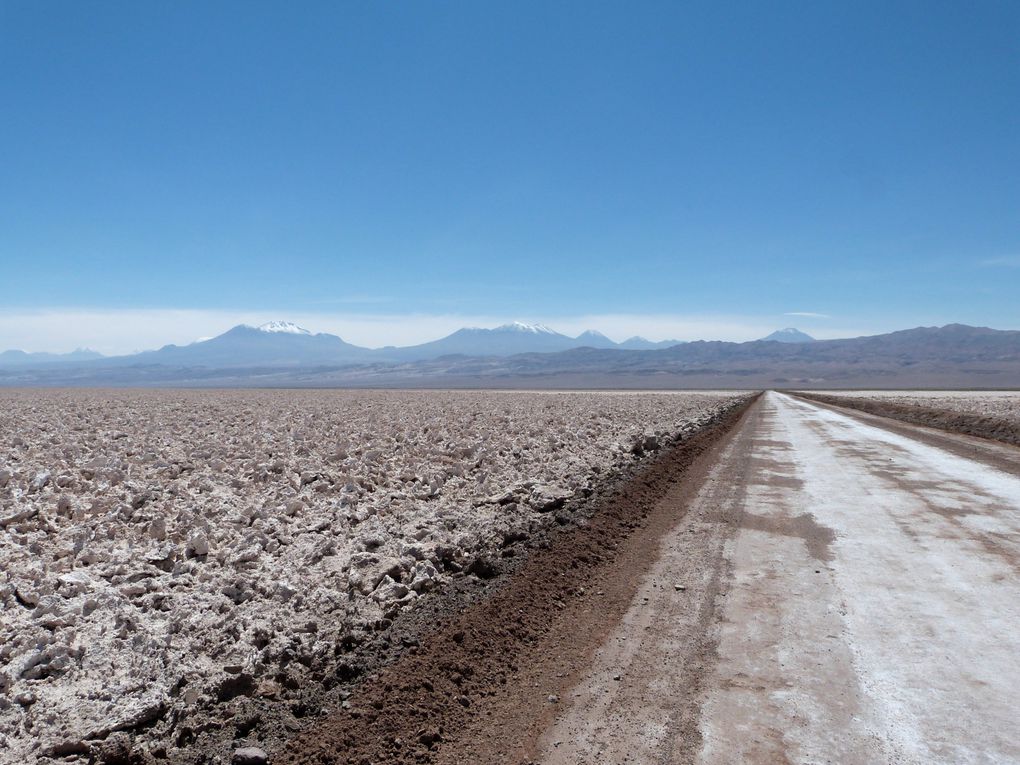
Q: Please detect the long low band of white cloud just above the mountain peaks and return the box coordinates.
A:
[0,308,881,355]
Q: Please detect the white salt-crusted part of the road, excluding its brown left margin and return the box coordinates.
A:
[701,394,1020,763]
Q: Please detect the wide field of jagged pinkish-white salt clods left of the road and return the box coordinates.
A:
[0,391,736,763]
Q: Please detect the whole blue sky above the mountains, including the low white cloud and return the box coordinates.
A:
[0,0,1020,352]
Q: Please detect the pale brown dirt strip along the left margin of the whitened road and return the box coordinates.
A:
[538,397,767,765]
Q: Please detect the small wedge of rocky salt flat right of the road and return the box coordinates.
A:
[800,391,1020,446]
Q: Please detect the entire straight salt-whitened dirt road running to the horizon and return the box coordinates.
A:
[534,393,1020,765]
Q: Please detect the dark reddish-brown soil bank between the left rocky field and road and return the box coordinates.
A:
[273,399,755,765]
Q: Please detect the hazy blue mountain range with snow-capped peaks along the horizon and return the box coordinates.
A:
[0,322,1020,389]
